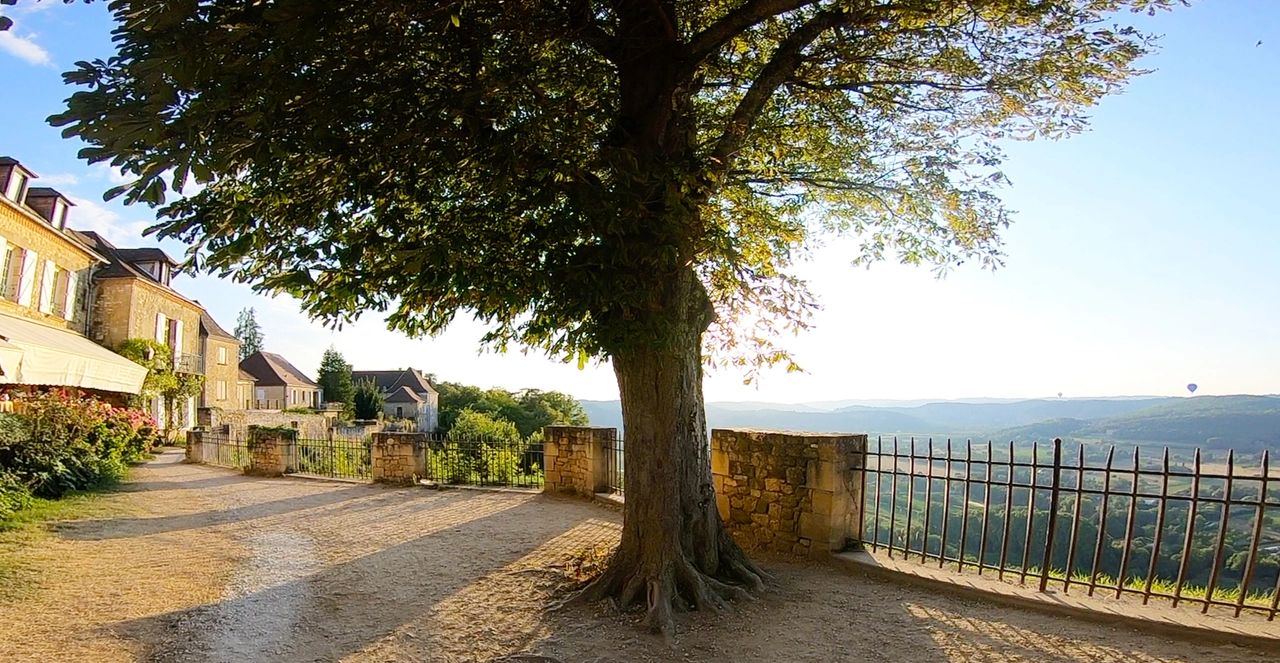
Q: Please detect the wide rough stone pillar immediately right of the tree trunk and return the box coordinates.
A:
[712,429,867,558]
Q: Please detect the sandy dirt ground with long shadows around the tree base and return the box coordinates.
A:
[0,453,1277,663]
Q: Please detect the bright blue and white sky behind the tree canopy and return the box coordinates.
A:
[0,0,1280,402]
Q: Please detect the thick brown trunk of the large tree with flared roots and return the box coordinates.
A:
[581,270,765,636]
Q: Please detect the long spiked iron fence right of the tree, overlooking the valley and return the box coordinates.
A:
[861,438,1280,619]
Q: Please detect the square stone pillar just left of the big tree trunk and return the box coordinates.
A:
[543,426,618,497]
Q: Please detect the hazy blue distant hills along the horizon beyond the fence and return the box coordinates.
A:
[582,395,1280,451]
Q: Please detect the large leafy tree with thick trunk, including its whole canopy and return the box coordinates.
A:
[52,0,1174,631]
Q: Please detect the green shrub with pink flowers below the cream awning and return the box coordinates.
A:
[0,389,156,498]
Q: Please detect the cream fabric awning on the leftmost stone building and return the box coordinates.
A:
[0,314,147,394]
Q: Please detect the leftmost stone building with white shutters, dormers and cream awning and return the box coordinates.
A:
[0,156,146,402]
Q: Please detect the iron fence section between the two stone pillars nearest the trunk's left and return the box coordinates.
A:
[425,434,544,488]
